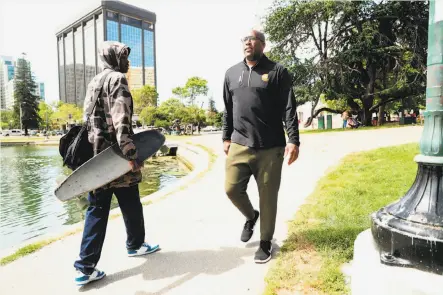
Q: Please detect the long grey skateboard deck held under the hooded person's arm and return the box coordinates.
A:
[54,130,165,202]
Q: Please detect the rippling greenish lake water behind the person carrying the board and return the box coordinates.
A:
[0,146,186,249]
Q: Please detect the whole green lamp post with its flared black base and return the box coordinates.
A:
[371,0,443,274]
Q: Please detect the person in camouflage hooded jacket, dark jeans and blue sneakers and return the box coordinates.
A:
[74,41,159,285]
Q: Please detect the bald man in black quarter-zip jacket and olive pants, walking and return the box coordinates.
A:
[223,30,300,263]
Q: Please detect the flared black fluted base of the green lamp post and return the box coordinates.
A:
[371,163,443,275]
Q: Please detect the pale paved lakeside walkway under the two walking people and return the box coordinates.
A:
[0,127,422,295]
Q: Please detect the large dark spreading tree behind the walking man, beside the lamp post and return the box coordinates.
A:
[265,0,427,126]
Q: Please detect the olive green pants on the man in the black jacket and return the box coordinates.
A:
[225,143,285,241]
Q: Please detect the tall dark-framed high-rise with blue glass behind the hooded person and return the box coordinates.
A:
[57,0,157,106]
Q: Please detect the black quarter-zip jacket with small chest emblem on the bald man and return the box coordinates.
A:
[223,55,300,148]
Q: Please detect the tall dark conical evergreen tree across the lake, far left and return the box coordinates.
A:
[14,55,40,135]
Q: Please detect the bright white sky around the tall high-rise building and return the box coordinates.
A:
[0,0,273,111]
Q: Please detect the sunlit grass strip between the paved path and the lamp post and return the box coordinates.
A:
[265,144,419,295]
